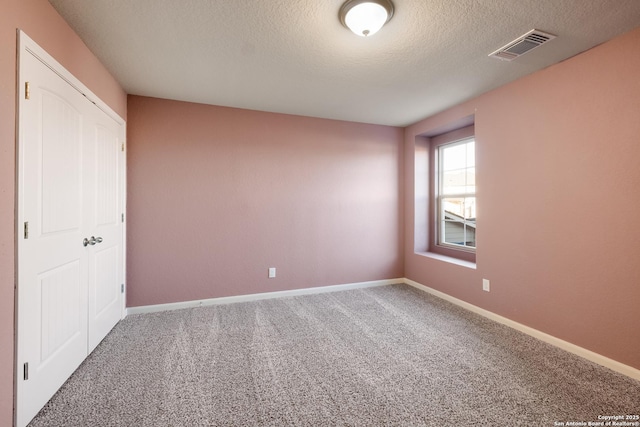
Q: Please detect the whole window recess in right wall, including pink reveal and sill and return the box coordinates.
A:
[413,115,477,268]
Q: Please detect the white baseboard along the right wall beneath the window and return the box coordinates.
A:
[403,278,640,381]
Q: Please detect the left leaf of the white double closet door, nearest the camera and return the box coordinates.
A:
[17,48,89,425]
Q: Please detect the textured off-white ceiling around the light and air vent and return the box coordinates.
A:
[50,0,640,126]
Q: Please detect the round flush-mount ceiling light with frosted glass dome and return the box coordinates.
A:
[339,0,393,37]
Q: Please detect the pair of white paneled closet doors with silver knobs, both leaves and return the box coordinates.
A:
[16,37,125,427]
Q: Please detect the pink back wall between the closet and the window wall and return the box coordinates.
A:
[127,96,403,306]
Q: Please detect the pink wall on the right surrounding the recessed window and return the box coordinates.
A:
[405,28,640,369]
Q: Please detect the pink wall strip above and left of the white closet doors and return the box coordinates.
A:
[0,0,127,426]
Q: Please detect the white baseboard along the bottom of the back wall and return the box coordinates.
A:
[127,279,405,315]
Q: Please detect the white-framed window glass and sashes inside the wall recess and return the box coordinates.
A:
[435,137,476,252]
